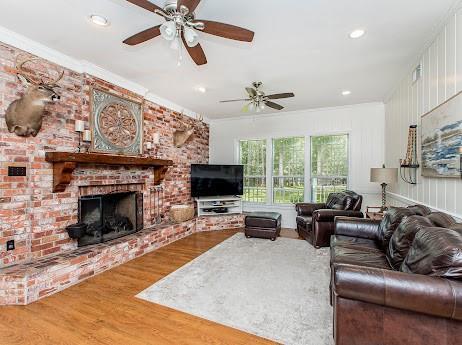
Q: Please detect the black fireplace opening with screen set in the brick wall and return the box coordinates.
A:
[78,192,143,247]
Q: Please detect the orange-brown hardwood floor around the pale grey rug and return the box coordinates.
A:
[0,230,297,345]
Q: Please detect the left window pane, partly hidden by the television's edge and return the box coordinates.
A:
[239,140,266,202]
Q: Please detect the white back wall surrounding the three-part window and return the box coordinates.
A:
[210,103,385,228]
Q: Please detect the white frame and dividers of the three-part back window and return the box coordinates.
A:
[234,131,354,209]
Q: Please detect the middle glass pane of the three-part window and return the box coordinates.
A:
[273,137,305,204]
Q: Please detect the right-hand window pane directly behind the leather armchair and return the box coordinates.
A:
[311,135,348,202]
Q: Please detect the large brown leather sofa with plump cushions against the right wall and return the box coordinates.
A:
[331,206,462,345]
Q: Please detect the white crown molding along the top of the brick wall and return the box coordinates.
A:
[0,26,206,123]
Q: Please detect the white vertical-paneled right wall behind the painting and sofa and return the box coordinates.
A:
[385,8,462,218]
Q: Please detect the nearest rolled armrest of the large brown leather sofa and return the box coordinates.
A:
[332,264,462,320]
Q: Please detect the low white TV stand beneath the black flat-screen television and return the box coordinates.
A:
[196,195,242,217]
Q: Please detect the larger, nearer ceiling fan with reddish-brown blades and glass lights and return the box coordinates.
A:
[124,0,254,65]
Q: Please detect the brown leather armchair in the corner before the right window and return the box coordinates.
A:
[295,191,363,248]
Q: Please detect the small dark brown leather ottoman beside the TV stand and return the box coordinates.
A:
[245,212,281,241]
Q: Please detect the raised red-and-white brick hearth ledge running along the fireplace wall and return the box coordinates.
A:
[0,215,244,305]
